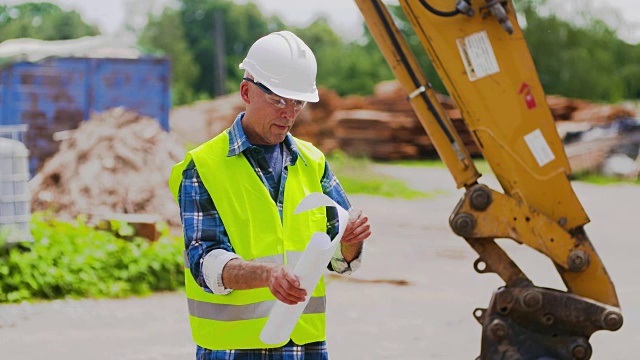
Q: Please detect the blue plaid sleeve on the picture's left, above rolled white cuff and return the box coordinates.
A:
[178,161,235,292]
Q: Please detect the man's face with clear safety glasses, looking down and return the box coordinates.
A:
[240,81,302,145]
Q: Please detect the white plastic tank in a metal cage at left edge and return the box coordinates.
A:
[0,137,33,243]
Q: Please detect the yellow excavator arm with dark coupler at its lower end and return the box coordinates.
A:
[355,0,623,360]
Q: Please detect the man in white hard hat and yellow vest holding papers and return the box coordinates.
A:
[170,31,371,360]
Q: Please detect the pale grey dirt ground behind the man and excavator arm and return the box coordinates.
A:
[0,166,640,360]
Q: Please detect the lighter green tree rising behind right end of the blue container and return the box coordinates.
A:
[139,8,200,105]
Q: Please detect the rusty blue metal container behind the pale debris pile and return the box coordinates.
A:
[0,58,171,176]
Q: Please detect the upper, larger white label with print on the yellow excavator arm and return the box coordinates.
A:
[456,31,500,81]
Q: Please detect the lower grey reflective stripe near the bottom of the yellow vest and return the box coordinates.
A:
[187,296,327,321]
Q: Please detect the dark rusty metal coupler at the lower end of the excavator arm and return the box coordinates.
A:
[480,286,622,360]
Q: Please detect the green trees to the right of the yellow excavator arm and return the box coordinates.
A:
[516,0,640,102]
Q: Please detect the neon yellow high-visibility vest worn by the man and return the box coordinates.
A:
[169,131,327,350]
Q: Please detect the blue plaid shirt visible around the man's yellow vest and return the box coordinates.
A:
[178,113,360,360]
